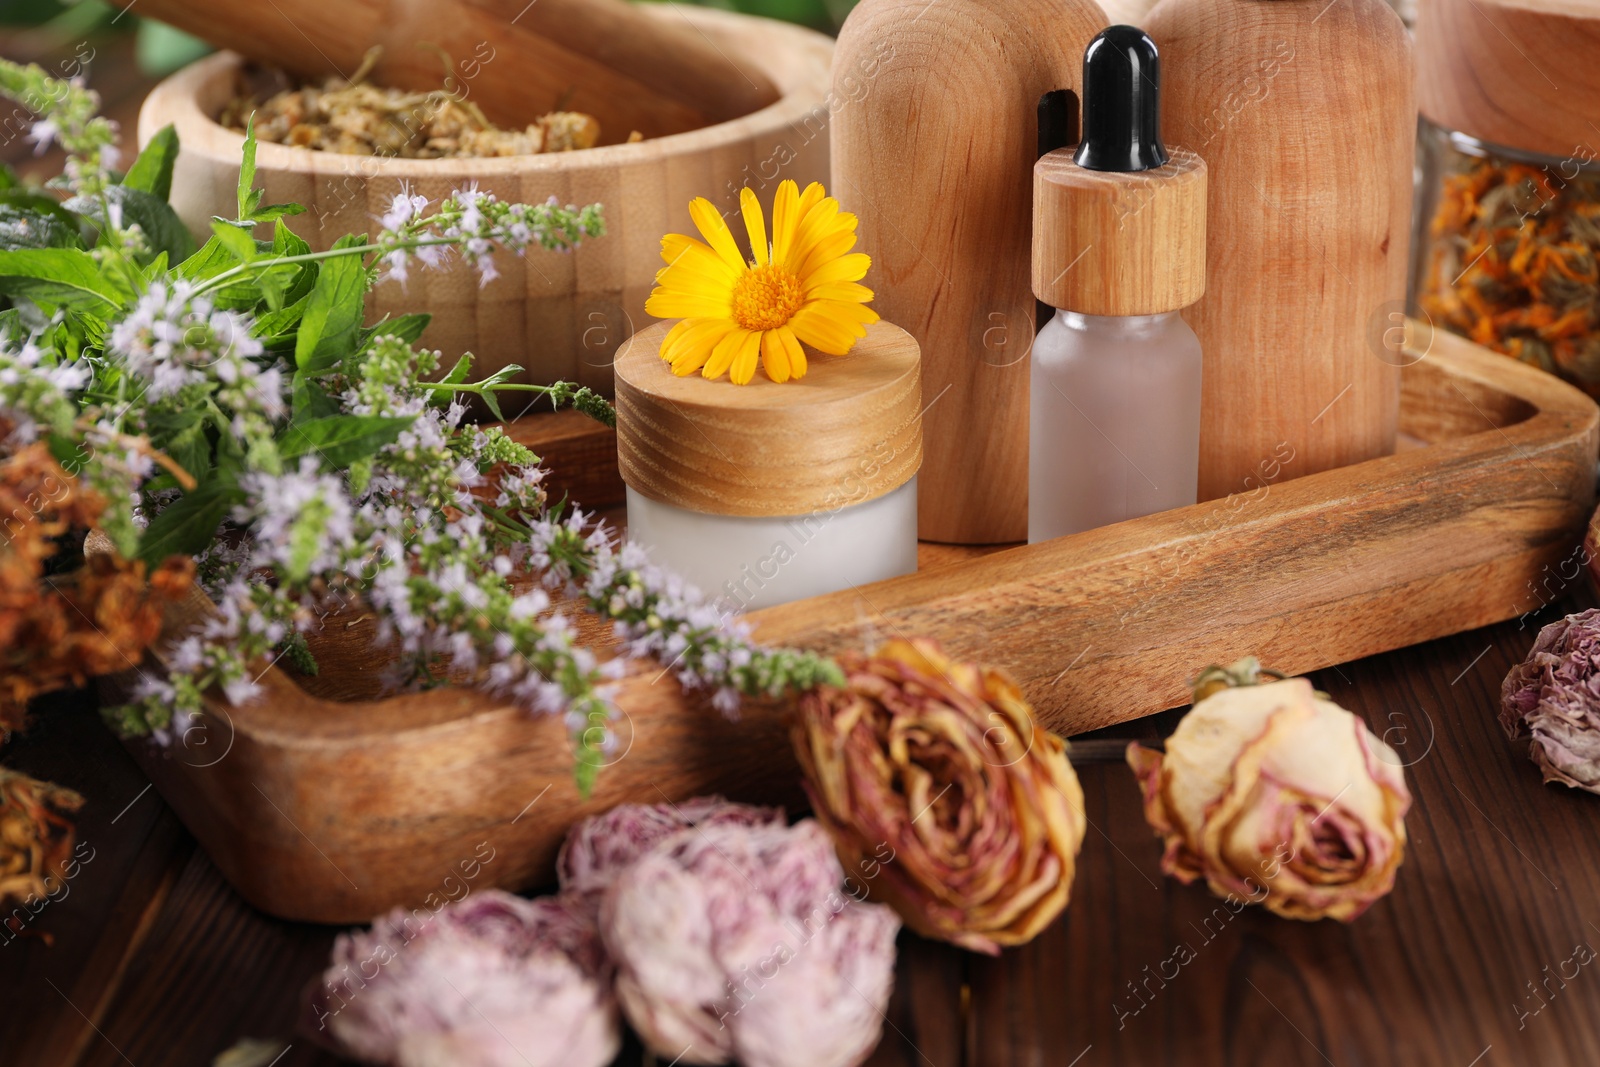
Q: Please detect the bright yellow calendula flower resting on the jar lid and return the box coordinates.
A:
[645,181,878,386]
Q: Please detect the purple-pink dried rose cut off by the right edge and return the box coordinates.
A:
[1501,608,1600,793]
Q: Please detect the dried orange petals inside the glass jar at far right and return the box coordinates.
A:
[1419,155,1600,397]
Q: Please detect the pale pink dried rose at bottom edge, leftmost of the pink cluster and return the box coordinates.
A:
[312,889,621,1067]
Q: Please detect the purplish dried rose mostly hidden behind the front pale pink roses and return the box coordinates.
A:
[555,797,784,894]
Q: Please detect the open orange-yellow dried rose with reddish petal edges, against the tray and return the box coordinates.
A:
[794,641,1085,953]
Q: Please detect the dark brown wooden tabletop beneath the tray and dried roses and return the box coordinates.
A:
[9,601,1600,1067]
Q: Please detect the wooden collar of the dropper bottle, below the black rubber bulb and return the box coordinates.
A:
[1034,147,1206,315]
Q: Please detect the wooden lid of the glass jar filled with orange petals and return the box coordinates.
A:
[1420,0,1600,160]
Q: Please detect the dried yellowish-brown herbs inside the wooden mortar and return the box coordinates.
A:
[218,50,617,160]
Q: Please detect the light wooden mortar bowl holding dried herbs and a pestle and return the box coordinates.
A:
[139,5,834,398]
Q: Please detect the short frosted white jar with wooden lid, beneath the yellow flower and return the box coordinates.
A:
[616,323,922,609]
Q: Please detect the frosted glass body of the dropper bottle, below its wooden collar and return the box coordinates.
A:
[1027,310,1200,542]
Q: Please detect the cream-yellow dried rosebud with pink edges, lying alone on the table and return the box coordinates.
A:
[1128,659,1411,921]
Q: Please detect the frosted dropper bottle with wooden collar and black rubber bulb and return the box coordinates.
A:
[1027,26,1206,542]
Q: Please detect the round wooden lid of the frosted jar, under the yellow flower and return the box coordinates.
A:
[616,322,922,515]
